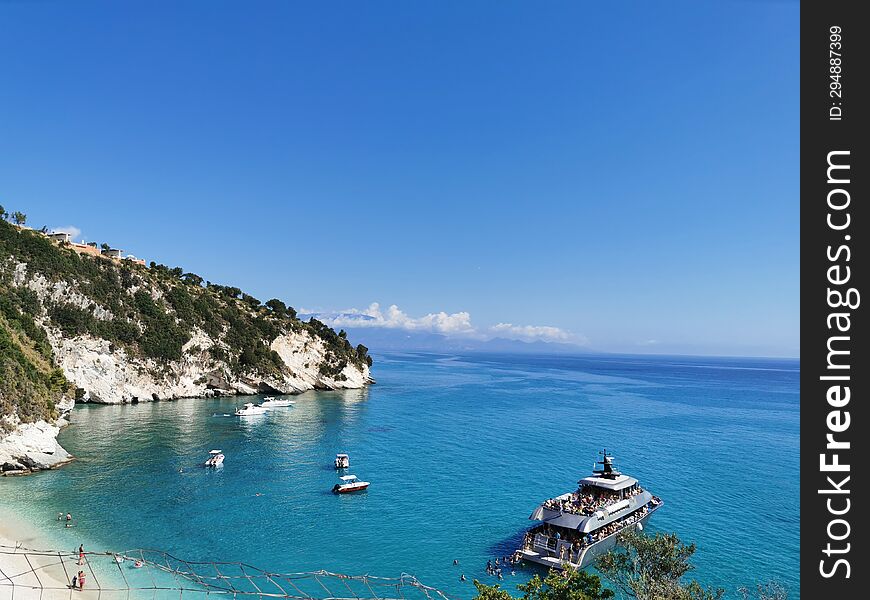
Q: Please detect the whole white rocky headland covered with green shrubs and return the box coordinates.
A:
[0,220,372,473]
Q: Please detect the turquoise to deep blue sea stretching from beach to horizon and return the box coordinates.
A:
[0,354,800,598]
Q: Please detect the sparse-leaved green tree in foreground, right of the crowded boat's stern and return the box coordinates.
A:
[595,530,725,600]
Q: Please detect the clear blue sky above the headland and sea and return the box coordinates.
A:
[0,0,799,356]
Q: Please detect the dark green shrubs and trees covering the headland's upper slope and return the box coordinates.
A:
[0,216,371,421]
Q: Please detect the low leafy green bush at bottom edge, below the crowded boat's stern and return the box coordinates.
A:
[474,569,614,600]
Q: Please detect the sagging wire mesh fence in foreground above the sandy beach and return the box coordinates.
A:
[0,545,454,600]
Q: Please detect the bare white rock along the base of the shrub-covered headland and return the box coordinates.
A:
[0,332,374,476]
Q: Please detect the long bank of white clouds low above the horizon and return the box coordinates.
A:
[310,302,586,344]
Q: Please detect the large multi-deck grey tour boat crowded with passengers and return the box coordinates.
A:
[517,450,663,569]
